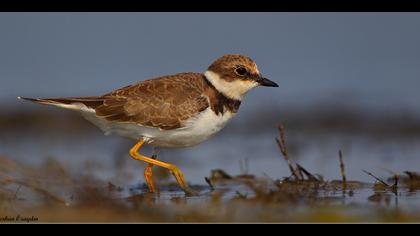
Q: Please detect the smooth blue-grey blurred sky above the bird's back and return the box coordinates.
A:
[0,13,420,114]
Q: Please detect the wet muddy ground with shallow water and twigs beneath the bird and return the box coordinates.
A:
[0,108,420,222]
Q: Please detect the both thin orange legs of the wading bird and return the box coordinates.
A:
[129,139,192,194]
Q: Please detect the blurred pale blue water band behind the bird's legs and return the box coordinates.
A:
[0,127,420,184]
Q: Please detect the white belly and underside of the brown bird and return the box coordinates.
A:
[81,108,235,147]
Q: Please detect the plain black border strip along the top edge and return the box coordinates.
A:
[0,0,420,12]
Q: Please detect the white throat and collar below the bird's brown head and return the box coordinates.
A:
[204,70,258,101]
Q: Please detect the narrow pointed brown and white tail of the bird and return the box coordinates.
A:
[18,97,104,110]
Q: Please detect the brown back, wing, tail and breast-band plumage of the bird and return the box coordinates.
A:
[22,72,240,130]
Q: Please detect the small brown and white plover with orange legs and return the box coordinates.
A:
[18,54,278,194]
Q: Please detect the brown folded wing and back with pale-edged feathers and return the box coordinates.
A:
[95,73,209,130]
